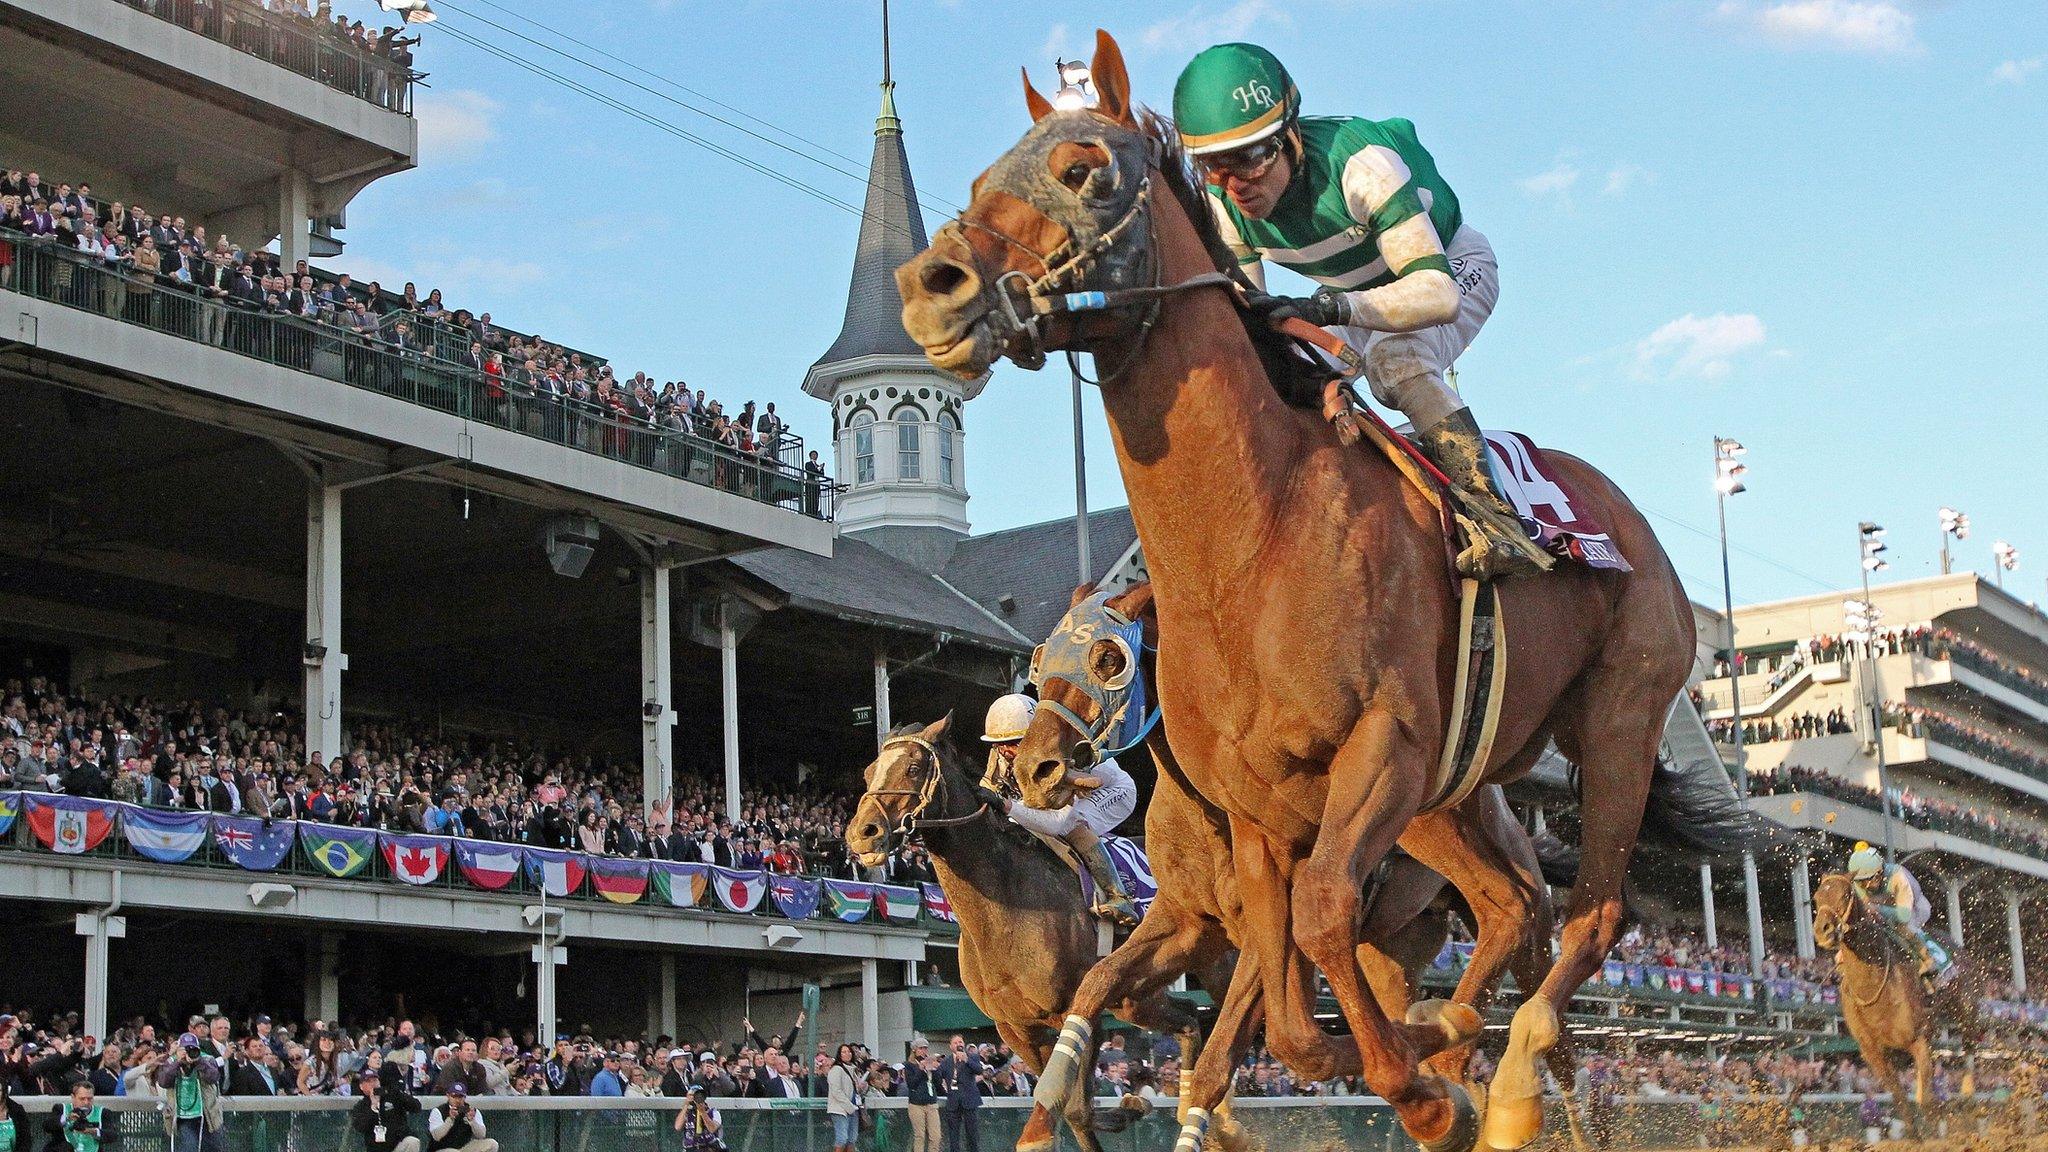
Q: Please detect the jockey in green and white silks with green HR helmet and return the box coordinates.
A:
[1174,43,1536,578]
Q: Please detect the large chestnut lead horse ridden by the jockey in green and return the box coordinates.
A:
[897,33,1736,1152]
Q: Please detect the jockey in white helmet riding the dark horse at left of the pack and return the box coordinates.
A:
[979,693,1139,924]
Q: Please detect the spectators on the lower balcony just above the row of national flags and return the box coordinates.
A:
[0,676,932,883]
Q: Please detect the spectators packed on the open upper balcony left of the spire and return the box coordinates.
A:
[0,170,825,504]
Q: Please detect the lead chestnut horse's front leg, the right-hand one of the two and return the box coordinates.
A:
[1292,709,1479,1152]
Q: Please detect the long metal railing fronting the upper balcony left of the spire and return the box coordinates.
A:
[0,234,838,521]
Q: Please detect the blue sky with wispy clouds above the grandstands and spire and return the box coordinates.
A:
[332,0,2048,603]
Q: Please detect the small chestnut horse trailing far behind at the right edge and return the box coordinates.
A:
[1812,871,1985,1115]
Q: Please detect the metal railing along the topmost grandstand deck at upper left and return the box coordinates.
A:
[115,0,416,115]
